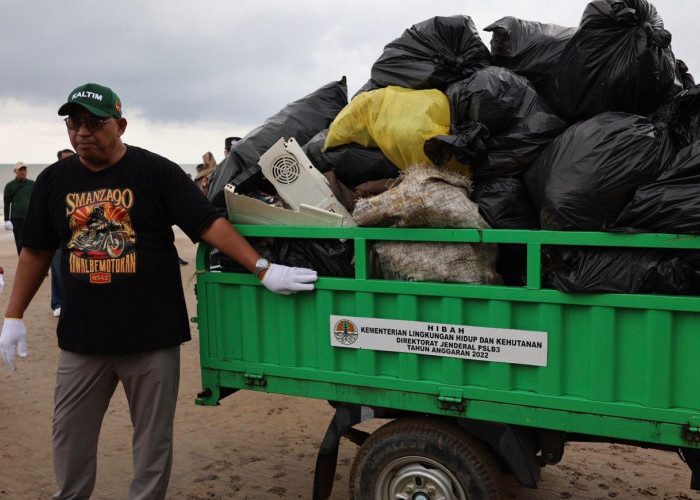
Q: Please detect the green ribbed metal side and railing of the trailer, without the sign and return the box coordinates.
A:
[197,226,700,446]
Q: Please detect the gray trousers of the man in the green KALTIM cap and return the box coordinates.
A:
[52,346,180,500]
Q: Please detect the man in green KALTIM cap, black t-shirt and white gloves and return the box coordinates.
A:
[0,83,316,500]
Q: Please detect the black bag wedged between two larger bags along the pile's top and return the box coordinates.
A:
[484,16,576,92]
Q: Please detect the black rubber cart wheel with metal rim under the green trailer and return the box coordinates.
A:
[350,417,503,500]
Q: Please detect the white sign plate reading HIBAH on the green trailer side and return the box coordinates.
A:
[330,315,547,366]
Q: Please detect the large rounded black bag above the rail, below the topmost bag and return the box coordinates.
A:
[525,112,673,231]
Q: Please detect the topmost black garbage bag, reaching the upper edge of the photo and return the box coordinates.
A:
[543,0,680,122]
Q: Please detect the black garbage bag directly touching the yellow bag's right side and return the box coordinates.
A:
[425,66,567,179]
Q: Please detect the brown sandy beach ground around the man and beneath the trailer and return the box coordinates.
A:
[0,231,700,500]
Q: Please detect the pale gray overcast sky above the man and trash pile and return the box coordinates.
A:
[0,0,700,164]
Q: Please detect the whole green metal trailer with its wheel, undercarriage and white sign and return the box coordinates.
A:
[194,225,700,500]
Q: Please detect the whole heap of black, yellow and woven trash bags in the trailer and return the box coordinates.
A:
[209,0,700,294]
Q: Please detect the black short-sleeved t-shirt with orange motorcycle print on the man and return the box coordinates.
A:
[22,146,219,354]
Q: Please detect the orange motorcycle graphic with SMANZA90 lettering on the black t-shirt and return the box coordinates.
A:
[66,189,136,284]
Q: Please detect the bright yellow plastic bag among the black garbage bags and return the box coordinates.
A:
[322,87,450,170]
